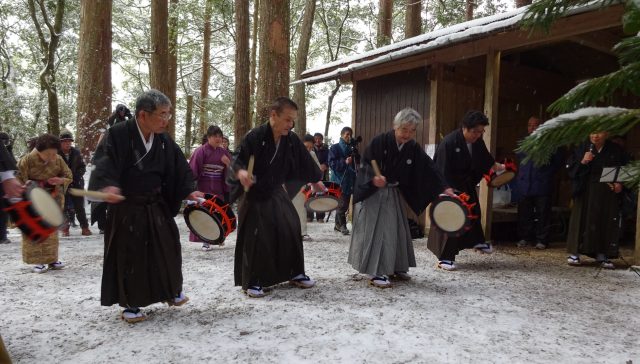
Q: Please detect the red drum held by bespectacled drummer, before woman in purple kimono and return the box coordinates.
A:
[183,194,237,245]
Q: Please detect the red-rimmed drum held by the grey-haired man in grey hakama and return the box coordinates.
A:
[429,193,478,237]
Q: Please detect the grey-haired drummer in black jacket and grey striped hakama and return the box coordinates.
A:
[348,108,453,288]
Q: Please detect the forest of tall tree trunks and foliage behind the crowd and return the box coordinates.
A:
[0,0,526,157]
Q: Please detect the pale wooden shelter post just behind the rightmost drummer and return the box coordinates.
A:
[479,50,500,240]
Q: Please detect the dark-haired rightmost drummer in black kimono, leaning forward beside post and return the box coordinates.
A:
[427,111,504,270]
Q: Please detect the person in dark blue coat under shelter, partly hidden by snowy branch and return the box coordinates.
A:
[516,116,562,249]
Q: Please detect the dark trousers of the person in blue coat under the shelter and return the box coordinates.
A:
[518,195,551,245]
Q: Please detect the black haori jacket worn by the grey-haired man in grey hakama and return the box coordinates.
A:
[353,130,446,215]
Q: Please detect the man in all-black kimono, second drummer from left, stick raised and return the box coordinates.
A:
[231,97,322,297]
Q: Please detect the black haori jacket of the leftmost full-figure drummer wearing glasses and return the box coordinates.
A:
[89,119,194,216]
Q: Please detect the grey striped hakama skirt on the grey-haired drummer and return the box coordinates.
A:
[348,187,416,276]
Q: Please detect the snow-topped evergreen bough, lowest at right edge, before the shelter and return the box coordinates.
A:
[517,107,640,165]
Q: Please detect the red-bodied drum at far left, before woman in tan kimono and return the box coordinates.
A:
[4,184,64,243]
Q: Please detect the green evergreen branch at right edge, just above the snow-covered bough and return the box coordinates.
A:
[548,61,640,113]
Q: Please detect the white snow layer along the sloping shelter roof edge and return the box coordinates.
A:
[292,1,602,84]
